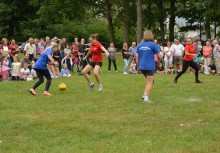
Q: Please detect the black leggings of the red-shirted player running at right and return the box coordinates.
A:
[175,60,199,81]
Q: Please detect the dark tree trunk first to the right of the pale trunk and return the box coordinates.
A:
[157,0,164,42]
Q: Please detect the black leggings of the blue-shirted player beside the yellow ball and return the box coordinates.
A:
[33,69,52,91]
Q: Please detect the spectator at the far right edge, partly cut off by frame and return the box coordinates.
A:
[213,40,220,75]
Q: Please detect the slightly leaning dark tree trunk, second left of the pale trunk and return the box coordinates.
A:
[106,0,115,42]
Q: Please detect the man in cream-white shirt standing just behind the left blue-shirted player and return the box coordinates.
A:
[24,38,36,61]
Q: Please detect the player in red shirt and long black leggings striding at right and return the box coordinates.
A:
[173,38,201,83]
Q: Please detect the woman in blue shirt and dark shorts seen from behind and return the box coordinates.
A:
[136,30,160,103]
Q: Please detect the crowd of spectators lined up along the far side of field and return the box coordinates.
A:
[0,36,220,82]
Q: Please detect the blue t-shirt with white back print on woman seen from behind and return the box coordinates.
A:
[137,41,160,71]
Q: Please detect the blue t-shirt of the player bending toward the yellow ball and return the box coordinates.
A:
[34,48,53,70]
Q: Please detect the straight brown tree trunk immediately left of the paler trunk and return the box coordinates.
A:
[124,0,129,43]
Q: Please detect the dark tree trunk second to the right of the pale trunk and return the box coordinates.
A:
[169,0,176,42]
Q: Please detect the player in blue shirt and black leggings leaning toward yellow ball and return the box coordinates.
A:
[29,43,59,96]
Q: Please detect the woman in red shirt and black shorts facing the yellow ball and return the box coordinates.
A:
[82,34,109,91]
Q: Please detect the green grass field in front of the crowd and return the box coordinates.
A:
[0,55,220,153]
